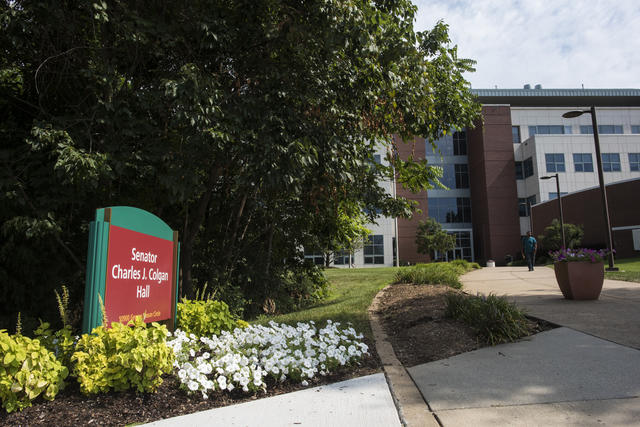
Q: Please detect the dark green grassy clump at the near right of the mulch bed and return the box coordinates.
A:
[445,292,529,345]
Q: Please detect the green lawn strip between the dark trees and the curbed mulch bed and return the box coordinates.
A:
[252,267,398,339]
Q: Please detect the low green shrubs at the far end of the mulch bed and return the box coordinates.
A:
[394,260,480,289]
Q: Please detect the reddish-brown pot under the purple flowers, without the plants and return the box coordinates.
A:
[553,261,604,300]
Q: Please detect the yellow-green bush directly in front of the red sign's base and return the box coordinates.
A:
[71,316,173,394]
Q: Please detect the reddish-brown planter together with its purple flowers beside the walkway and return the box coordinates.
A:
[549,248,608,300]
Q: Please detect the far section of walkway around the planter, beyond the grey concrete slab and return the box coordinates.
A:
[461,267,640,349]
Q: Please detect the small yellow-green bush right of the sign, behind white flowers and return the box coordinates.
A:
[178,298,238,337]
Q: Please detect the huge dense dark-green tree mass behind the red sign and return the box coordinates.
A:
[0,0,479,328]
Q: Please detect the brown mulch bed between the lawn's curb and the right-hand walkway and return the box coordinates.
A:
[378,284,554,367]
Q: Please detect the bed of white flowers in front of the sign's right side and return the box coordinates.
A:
[167,320,368,398]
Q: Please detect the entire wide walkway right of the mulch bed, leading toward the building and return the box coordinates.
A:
[408,267,640,426]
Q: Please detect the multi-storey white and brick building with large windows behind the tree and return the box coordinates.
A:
[314,85,640,267]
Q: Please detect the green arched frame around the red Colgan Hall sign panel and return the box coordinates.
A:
[82,206,180,333]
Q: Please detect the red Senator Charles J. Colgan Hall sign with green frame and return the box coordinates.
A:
[83,206,179,332]
